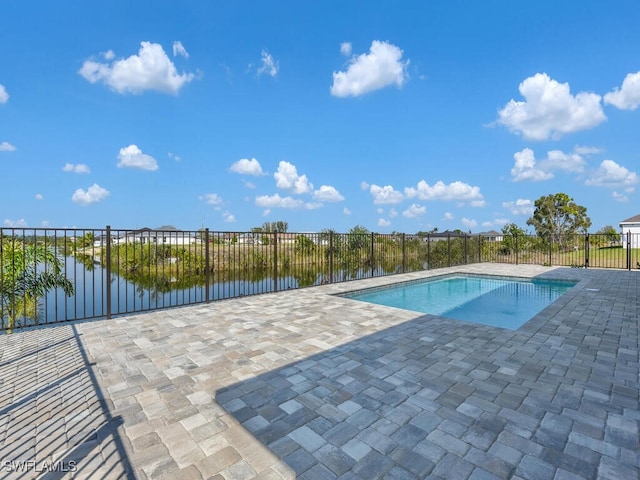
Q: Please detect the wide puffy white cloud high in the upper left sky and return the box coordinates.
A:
[78,42,195,95]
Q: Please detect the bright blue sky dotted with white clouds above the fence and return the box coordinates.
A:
[0,0,640,233]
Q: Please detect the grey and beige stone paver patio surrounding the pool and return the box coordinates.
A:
[0,264,640,480]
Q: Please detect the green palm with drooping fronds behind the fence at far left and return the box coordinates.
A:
[0,239,73,332]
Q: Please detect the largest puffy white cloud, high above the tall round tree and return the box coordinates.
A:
[498,73,607,140]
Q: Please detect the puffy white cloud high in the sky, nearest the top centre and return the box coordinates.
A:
[331,40,409,97]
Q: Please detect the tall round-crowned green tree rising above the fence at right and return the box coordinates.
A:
[527,193,591,246]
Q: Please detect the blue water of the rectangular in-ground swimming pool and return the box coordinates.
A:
[343,276,576,330]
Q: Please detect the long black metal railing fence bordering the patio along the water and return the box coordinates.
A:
[0,227,640,331]
